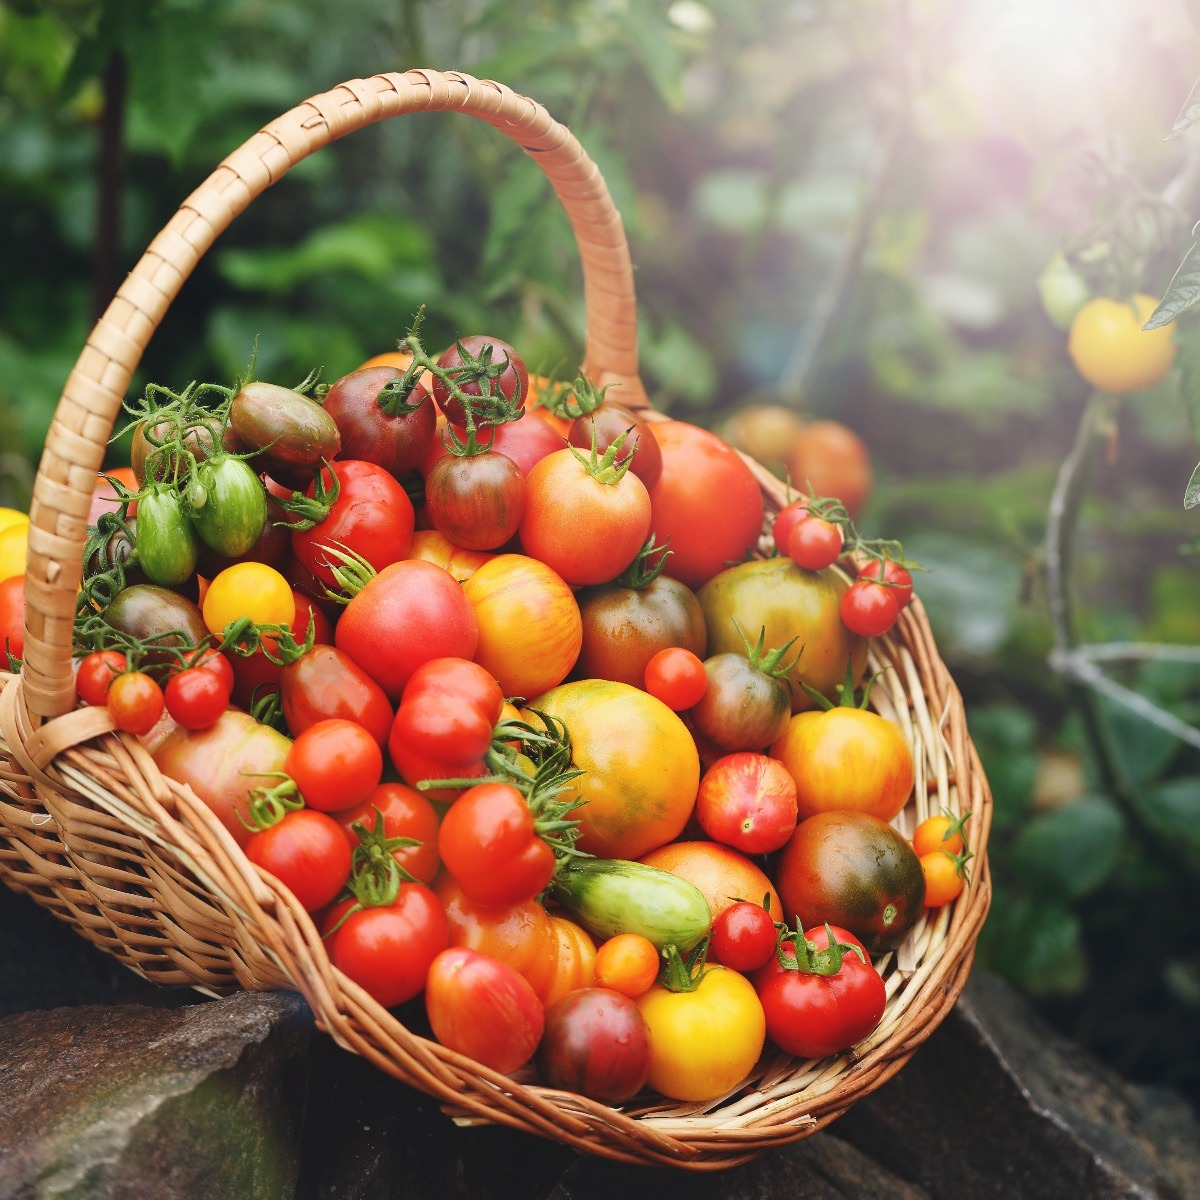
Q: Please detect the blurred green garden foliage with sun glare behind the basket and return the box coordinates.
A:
[0,0,1200,1088]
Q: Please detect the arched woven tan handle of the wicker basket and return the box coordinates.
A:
[22,70,648,724]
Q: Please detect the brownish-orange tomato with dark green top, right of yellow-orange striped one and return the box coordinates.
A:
[571,576,708,688]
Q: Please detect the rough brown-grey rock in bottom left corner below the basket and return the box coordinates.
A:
[0,994,312,1200]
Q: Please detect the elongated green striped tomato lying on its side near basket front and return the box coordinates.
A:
[551,858,713,952]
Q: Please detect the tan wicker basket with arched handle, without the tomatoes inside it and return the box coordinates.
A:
[0,71,991,1169]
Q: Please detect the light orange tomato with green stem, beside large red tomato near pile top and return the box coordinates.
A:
[521,449,650,586]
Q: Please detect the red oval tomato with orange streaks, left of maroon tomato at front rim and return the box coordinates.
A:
[425,947,545,1074]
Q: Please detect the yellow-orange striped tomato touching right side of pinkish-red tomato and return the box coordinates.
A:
[462,554,583,696]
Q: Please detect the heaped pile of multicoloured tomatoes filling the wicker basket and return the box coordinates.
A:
[0,332,970,1103]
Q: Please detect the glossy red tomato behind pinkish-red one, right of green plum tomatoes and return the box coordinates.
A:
[292,460,415,588]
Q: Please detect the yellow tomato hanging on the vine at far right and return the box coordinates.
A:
[1067,292,1176,396]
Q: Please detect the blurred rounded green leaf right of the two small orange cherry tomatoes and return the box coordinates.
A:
[1012,796,1126,900]
